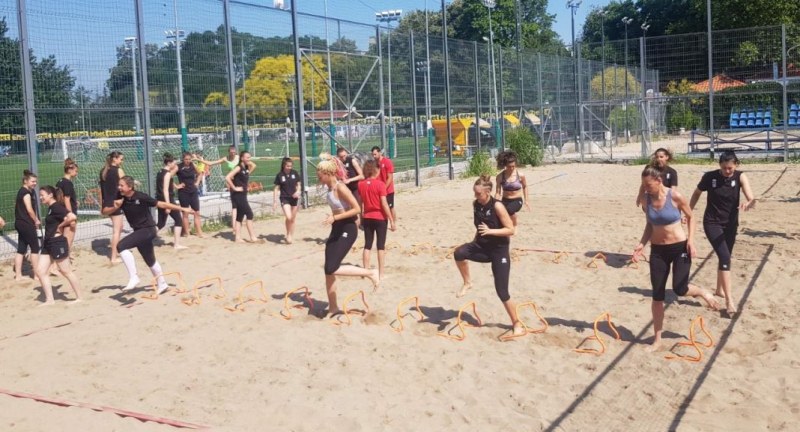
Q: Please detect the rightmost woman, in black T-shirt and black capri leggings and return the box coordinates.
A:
[689,151,756,314]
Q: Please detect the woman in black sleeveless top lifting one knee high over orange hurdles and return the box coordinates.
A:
[453,175,525,336]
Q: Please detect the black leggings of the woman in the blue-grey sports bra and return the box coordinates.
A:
[650,241,692,301]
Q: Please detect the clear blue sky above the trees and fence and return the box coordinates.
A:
[0,0,610,91]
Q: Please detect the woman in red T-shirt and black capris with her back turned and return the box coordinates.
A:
[358,161,396,279]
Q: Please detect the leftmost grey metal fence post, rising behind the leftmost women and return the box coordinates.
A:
[17,0,39,177]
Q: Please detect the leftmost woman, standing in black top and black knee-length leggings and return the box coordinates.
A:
[14,170,42,282]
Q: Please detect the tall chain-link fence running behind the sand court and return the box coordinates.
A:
[0,0,800,256]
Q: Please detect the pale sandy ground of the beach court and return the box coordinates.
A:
[0,160,800,431]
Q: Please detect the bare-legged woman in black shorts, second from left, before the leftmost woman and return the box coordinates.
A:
[36,186,81,305]
